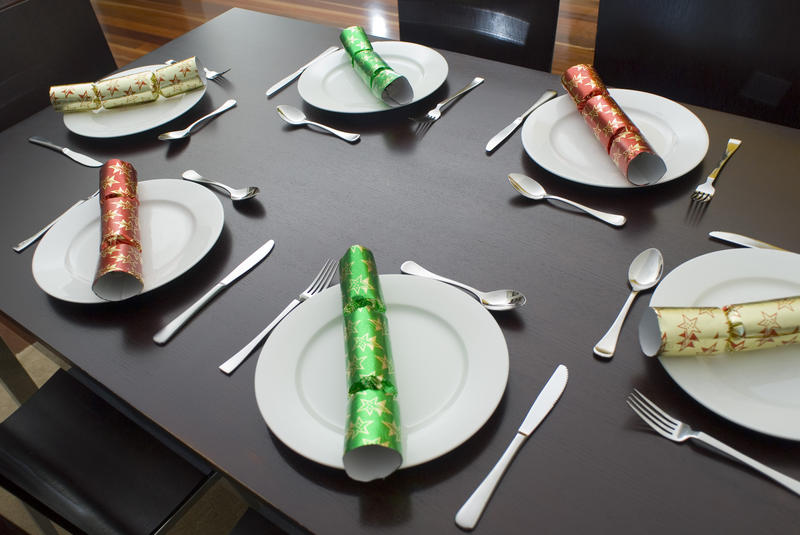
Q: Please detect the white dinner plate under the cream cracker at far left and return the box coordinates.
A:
[64,65,207,138]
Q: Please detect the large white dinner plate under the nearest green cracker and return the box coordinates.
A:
[255,275,508,468]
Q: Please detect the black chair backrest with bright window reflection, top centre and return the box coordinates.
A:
[397,0,558,71]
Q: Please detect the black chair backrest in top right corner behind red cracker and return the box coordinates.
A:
[594,0,800,127]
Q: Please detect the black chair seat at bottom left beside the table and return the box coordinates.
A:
[0,370,207,534]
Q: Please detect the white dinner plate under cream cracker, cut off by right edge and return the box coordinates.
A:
[650,249,800,440]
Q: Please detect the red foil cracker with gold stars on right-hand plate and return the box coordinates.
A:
[561,64,667,186]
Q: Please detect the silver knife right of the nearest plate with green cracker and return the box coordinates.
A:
[456,364,569,529]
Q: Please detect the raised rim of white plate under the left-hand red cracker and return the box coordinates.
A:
[31,178,225,304]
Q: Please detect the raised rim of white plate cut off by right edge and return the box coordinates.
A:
[649,248,800,441]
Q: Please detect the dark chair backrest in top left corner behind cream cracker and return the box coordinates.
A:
[0,0,117,130]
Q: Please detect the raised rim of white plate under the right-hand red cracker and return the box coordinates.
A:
[521,88,709,189]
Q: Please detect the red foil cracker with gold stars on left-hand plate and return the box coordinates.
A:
[92,159,144,301]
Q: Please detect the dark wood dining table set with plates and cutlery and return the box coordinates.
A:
[0,9,800,534]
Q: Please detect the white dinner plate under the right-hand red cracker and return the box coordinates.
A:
[522,89,708,188]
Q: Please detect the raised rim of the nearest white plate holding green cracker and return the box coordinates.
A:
[253,274,510,469]
